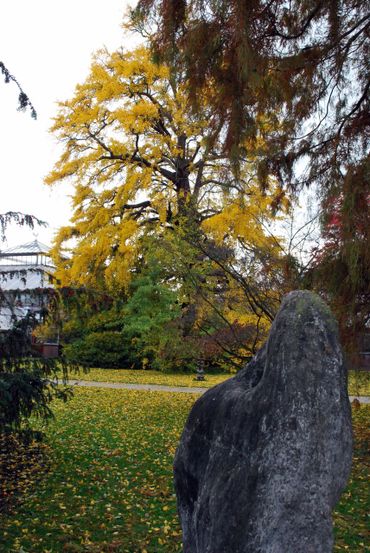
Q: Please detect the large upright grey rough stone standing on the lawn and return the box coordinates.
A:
[175,291,352,553]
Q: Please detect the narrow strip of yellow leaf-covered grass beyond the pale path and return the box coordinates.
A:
[70,369,370,396]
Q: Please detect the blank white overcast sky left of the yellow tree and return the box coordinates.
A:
[0,0,135,249]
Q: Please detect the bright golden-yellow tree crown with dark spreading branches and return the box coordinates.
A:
[46,47,290,366]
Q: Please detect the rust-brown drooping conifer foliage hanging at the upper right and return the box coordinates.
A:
[132,0,370,352]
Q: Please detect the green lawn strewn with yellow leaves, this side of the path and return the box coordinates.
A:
[0,388,370,553]
